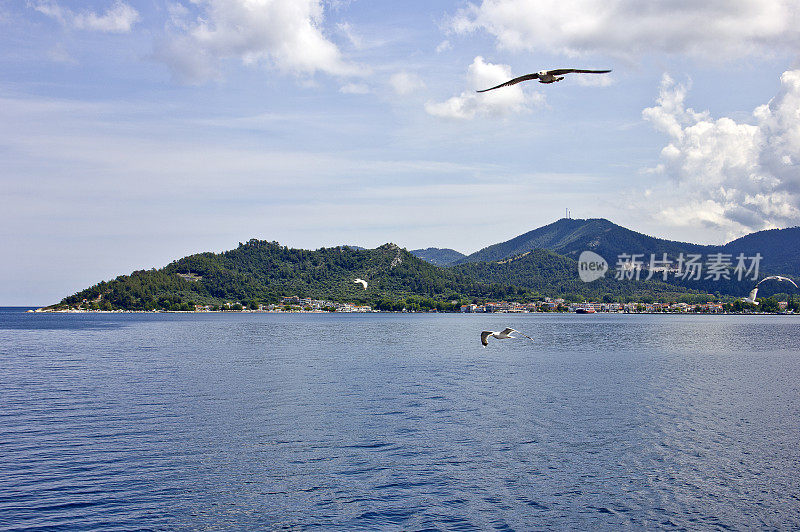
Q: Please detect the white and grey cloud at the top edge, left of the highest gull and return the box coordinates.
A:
[155,0,360,83]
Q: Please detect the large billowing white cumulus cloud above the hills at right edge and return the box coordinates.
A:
[642,70,800,234]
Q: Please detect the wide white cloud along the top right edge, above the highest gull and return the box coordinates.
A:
[450,0,800,57]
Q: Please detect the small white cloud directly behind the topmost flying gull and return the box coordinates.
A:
[425,56,544,120]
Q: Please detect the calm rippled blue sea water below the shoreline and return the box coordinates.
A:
[0,309,800,530]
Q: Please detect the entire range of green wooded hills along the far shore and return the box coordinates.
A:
[51,219,800,310]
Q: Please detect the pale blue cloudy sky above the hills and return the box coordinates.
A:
[0,0,800,306]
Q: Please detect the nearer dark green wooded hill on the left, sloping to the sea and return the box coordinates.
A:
[50,240,522,310]
